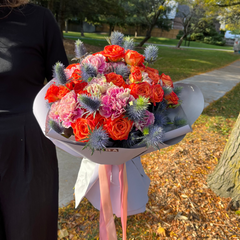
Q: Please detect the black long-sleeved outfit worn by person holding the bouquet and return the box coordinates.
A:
[0,4,68,240]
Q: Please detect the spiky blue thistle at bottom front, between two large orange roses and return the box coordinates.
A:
[83,127,109,154]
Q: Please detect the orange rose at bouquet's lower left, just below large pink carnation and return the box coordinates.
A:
[71,118,95,142]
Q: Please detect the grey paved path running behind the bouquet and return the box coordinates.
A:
[57,61,240,207]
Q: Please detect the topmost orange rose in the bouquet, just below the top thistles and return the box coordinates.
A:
[103,45,125,62]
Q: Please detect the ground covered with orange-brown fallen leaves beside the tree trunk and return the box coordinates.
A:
[58,40,240,240]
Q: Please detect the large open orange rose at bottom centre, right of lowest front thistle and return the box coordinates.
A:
[106,116,133,140]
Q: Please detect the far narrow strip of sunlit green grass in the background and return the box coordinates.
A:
[64,32,233,50]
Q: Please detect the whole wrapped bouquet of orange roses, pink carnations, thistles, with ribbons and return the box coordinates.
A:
[33,32,204,239]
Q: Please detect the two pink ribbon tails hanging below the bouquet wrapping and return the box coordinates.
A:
[99,163,128,240]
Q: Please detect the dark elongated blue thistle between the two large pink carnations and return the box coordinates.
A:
[78,94,101,113]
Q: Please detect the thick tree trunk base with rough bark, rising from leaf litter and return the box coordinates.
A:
[207,114,240,209]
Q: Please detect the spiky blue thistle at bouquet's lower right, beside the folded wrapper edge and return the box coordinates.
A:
[141,125,164,149]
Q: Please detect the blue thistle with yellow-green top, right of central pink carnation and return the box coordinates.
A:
[126,95,149,122]
